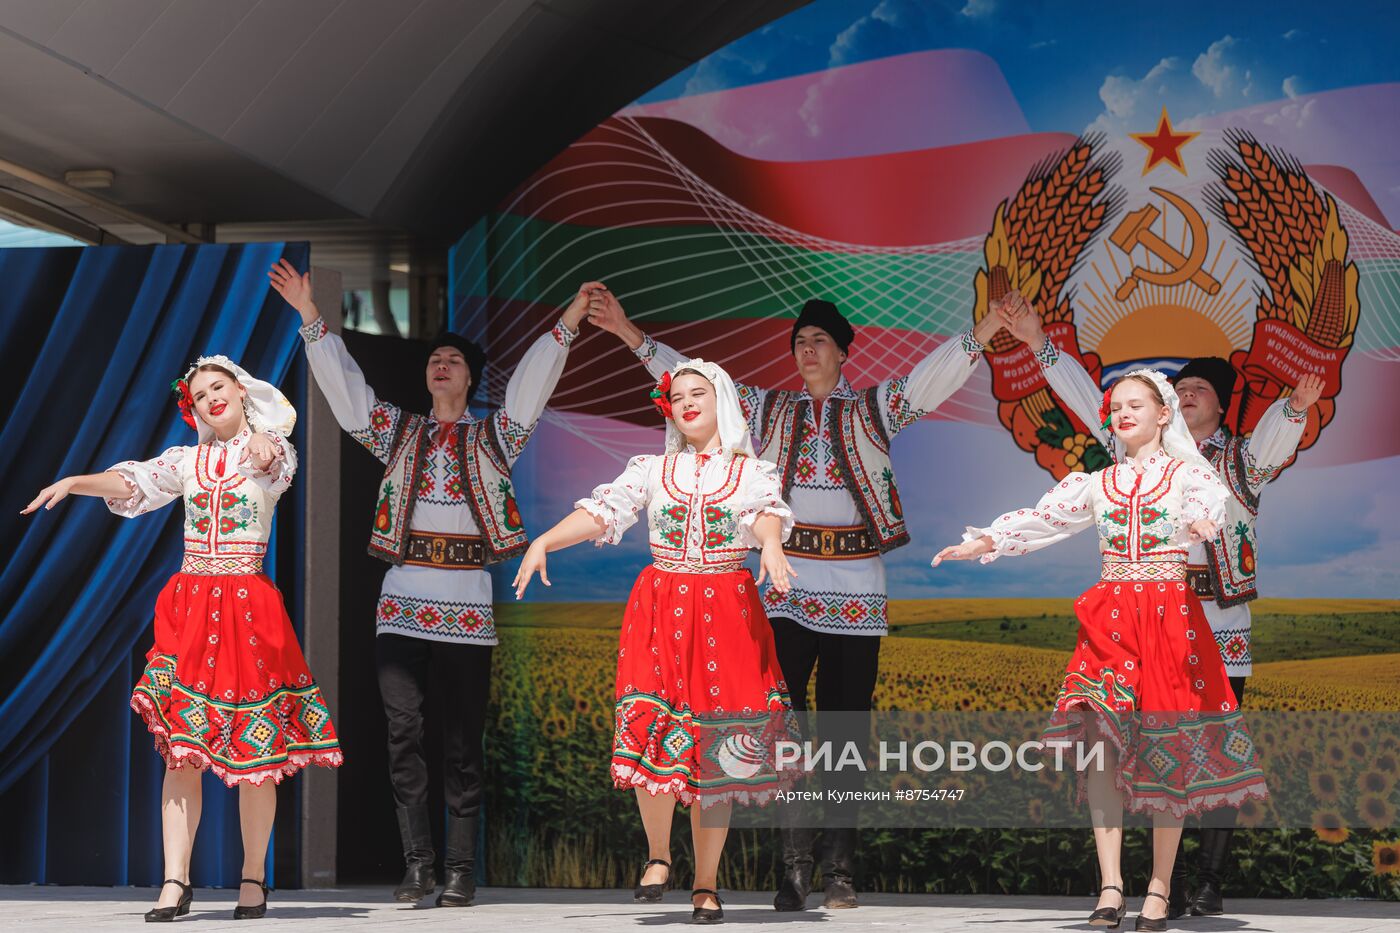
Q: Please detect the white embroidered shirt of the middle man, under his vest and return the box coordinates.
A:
[636,331,981,635]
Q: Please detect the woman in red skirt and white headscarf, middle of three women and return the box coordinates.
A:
[515,360,797,923]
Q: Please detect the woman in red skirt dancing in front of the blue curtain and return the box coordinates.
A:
[24,356,342,920]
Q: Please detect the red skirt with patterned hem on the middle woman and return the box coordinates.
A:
[612,566,798,807]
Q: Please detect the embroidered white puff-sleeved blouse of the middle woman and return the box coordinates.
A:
[574,447,792,573]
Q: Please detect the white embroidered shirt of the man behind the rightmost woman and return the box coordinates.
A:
[1036,340,1308,677]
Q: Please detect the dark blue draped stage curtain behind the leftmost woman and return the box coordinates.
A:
[0,244,309,885]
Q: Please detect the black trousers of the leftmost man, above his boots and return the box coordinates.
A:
[374,635,493,817]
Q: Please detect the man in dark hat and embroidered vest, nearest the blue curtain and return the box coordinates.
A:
[269,262,602,906]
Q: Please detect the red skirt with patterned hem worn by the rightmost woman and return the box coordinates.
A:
[1044,580,1268,817]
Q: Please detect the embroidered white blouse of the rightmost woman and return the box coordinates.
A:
[963,451,1229,571]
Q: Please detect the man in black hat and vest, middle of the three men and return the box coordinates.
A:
[588,290,1001,911]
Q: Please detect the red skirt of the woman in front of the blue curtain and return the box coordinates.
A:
[132,573,343,787]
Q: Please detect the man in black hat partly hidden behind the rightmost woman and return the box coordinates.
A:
[1000,293,1323,919]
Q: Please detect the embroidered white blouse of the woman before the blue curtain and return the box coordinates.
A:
[104,430,297,574]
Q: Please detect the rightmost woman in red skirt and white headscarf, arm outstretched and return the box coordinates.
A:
[934,370,1268,930]
